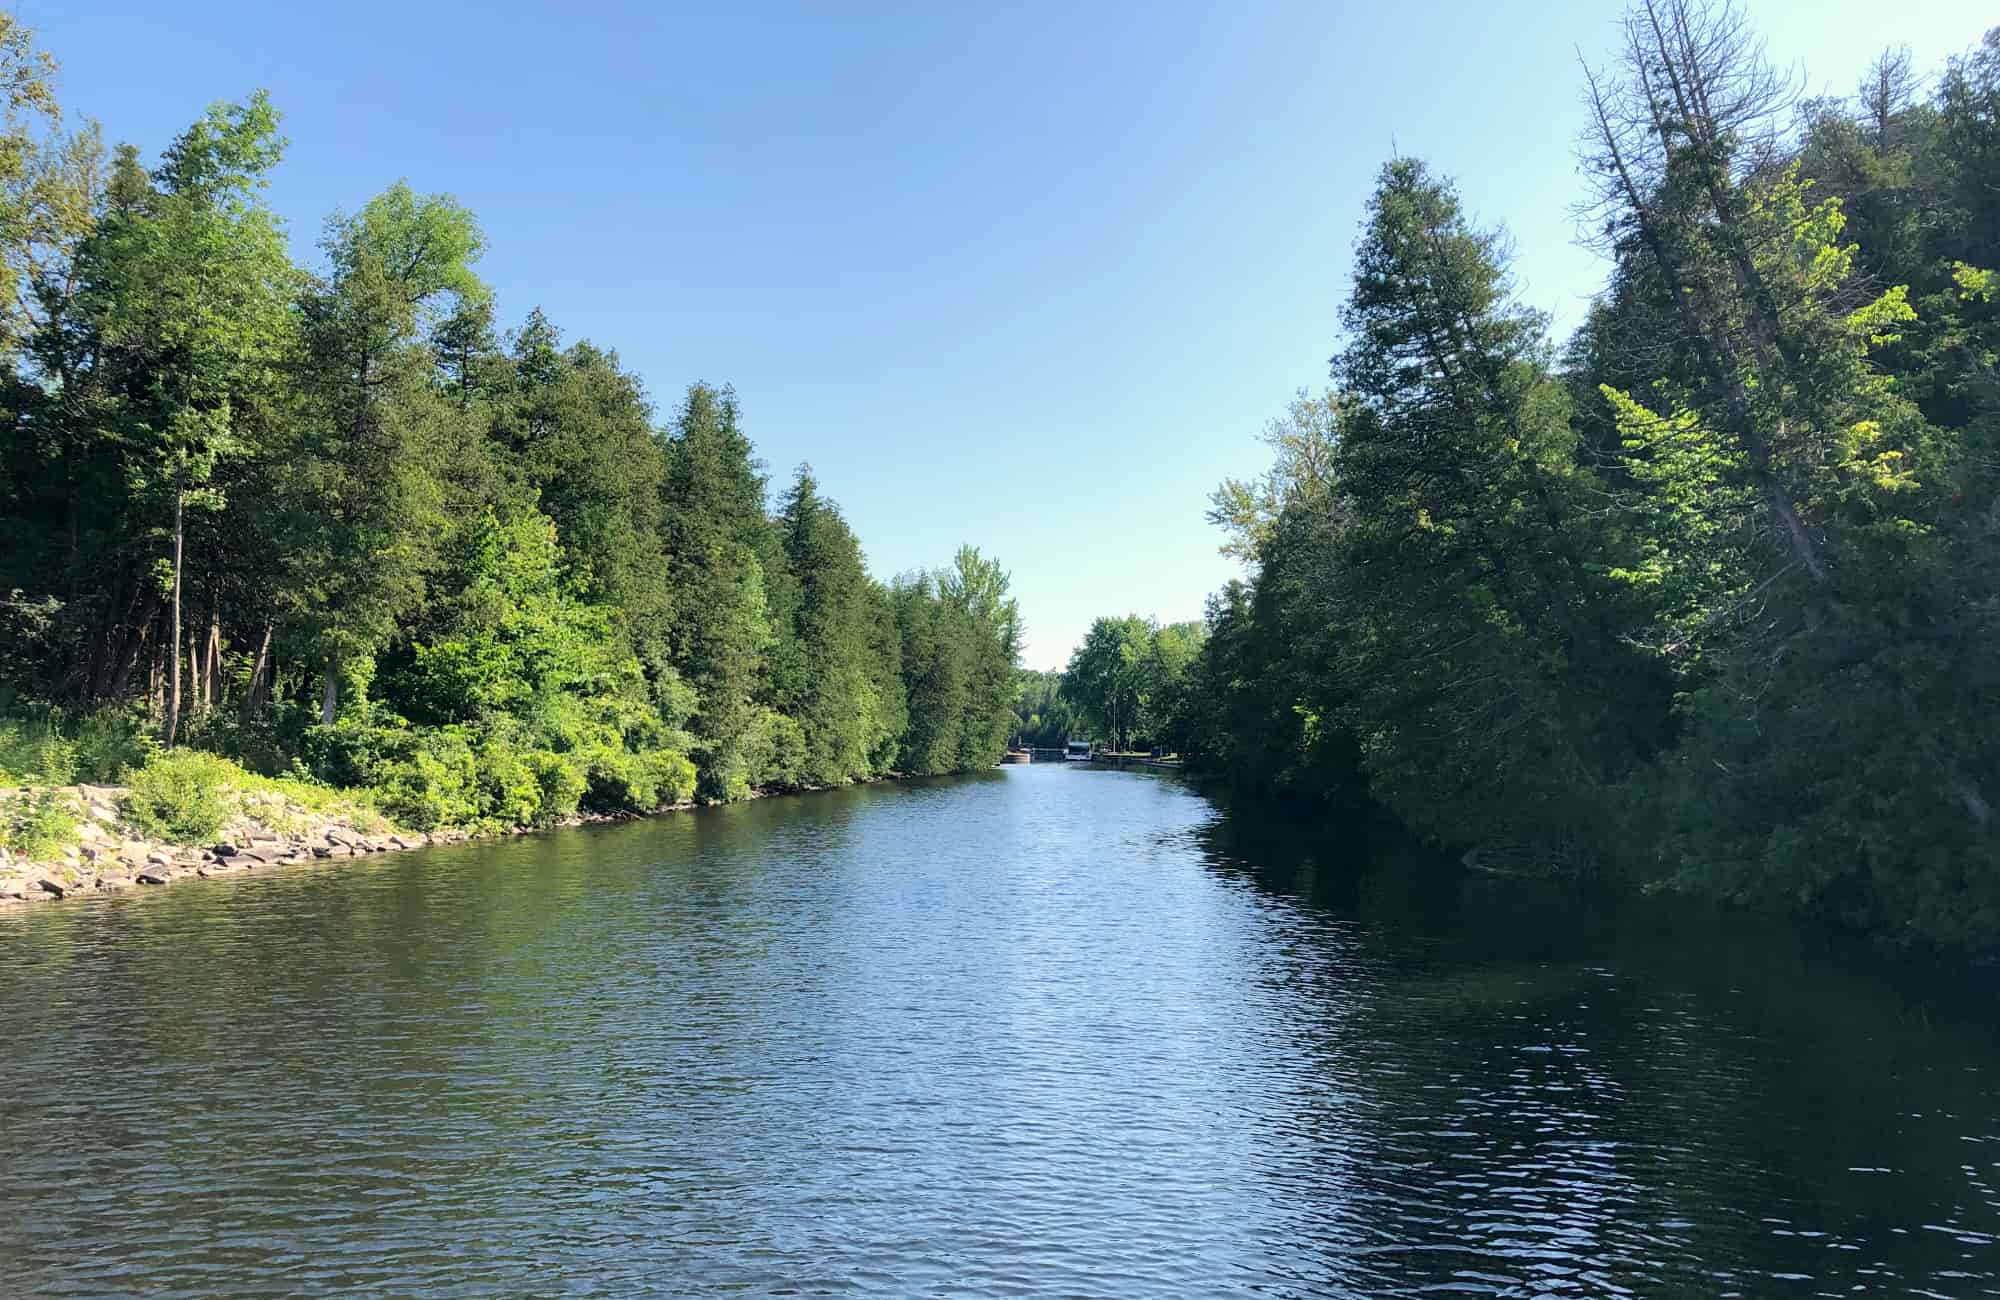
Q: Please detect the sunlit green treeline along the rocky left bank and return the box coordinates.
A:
[0,16,1020,826]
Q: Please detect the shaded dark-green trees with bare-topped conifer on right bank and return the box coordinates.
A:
[1174,0,2000,946]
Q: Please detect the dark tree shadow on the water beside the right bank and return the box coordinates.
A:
[1192,776,2000,1296]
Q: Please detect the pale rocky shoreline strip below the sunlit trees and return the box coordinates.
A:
[0,786,676,908]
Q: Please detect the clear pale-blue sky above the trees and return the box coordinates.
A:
[14,0,2000,668]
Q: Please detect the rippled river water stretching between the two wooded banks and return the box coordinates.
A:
[0,766,2000,1298]
